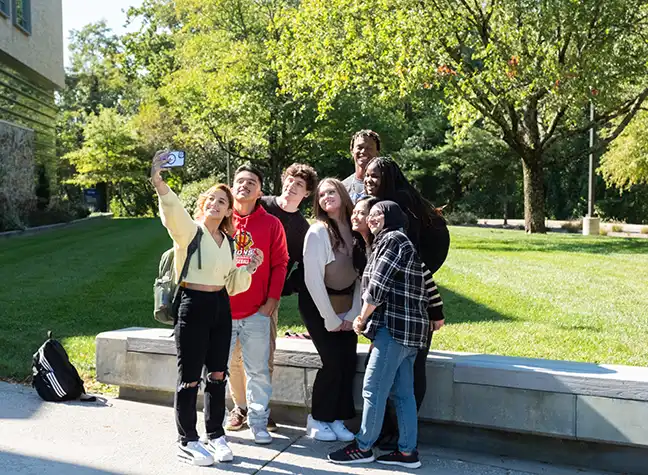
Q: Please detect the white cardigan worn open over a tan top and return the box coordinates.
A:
[304,222,362,331]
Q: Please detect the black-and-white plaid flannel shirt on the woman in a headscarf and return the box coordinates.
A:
[362,231,430,348]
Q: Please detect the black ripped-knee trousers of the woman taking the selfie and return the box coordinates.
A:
[174,288,232,443]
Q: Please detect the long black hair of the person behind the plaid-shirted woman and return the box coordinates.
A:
[367,157,445,228]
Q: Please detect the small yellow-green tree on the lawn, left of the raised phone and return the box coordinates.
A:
[65,108,157,216]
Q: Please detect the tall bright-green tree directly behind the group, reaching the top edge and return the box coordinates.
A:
[148,0,324,192]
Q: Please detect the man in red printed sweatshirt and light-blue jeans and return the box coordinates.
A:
[230,165,288,444]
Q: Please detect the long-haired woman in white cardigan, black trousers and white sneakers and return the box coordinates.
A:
[299,178,366,441]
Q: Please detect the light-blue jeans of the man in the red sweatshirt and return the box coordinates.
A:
[229,312,272,428]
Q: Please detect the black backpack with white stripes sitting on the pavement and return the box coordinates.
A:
[32,332,94,402]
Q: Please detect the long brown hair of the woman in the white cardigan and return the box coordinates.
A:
[313,178,367,272]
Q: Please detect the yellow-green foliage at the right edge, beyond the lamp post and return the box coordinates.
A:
[599,111,648,190]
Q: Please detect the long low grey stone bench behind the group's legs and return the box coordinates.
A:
[96,328,648,474]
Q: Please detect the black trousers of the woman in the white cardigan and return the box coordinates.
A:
[299,291,358,422]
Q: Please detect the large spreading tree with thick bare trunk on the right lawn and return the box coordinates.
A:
[276,0,648,232]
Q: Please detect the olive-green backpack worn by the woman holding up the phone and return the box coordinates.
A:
[153,226,234,325]
